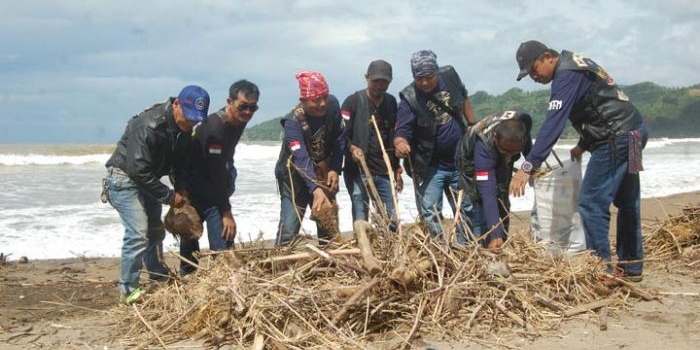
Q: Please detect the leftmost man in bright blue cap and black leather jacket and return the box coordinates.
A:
[105,85,209,303]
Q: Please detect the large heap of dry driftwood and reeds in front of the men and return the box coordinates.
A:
[117,216,654,349]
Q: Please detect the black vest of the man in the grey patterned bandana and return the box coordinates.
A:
[399,66,467,184]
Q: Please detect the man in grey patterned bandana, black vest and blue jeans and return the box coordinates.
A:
[394,50,476,244]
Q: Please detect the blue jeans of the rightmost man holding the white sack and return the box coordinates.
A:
[578,128,648,275]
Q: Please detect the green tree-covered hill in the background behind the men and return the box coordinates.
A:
[246,82,700,140]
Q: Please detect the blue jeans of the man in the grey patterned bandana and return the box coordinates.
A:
[416,166,481,244]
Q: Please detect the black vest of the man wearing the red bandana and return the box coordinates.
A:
[275,95,340,178]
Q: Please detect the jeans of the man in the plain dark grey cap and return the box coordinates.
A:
[343,172,394,222]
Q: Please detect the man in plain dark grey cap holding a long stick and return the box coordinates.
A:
[341,60,403,229]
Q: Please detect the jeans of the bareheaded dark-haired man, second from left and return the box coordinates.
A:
[180,205,234,276]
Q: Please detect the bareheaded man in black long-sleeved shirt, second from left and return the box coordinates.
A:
[180,80,260,275]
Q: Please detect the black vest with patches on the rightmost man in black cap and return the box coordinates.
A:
[557,51,642,150]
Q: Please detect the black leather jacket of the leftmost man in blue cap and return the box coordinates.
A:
[105,97,191,204]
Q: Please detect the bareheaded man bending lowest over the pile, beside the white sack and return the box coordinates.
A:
[455,111,532,249]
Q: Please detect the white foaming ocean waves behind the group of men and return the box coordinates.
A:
[0,139,700,260]
